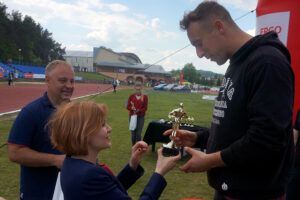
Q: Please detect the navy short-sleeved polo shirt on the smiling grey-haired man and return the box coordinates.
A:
[8,92,61,200]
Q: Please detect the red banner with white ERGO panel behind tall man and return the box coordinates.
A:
[256,0,300,120]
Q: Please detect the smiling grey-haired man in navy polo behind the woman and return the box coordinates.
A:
[8,60,74,200]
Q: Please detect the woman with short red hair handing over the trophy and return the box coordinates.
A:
[49,101,180,200]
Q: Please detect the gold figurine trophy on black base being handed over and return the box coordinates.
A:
[162,103,188,156]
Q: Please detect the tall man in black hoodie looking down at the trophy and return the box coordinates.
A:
[164,1,294,200]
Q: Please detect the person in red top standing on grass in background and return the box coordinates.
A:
[127,81,148,146]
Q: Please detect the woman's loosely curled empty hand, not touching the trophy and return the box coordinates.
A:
[129,141,150,170]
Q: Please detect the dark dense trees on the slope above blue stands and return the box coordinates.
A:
[0,2,65,64]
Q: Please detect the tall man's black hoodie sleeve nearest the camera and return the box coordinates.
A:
[221,59,294,168]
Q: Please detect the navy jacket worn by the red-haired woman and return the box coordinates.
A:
[61,156,167,200]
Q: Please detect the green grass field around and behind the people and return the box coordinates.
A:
[0,89,214,200]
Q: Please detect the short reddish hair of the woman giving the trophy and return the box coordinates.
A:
[48,101,108,156]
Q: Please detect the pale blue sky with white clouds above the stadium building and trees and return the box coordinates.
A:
[0,0,257,74]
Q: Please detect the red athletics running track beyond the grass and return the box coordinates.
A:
[0,83,126,114]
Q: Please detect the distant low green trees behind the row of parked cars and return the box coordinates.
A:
[171,63,224,86]
